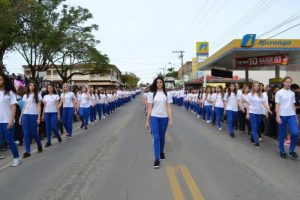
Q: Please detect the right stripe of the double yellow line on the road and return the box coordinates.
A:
[179,165,204,200]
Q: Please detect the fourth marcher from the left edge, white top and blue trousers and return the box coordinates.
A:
[60,83,77,139]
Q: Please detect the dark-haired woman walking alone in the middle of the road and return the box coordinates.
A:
[146,77,173,168]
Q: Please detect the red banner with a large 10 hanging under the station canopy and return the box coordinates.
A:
[235,54,289,68]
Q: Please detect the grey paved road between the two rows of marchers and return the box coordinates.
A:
[0,96,300,200]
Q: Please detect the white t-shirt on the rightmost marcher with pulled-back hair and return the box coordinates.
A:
[275,88,296,116]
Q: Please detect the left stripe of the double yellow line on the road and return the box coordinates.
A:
[167,164,184,200]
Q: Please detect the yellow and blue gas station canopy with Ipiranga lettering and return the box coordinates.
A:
[199,38,300,71]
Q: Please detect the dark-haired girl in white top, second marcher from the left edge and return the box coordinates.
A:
[19,82,43,158]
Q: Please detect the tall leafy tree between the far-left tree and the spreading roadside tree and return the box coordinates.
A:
[16,0,64,79]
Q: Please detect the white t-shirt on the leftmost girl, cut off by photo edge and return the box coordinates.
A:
[0,91,17,123]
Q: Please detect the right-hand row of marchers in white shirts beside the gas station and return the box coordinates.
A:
[172,77,299,160]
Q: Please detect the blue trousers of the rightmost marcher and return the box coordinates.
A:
[278,115,298,153]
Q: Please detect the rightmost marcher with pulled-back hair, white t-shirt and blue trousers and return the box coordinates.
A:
[275,77,299,160]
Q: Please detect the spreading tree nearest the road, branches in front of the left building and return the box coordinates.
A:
[49,5,111,82]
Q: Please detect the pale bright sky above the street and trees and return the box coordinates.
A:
[4,0,300,82]
